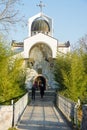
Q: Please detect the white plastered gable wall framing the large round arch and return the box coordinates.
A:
[24,33,57,58]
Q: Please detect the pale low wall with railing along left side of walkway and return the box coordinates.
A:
[0,93,28,130]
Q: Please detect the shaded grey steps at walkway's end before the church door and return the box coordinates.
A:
[29,90,56,104]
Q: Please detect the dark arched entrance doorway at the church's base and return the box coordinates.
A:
[34,75,46,90]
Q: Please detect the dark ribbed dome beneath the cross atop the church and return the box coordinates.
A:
[31,17,50,32]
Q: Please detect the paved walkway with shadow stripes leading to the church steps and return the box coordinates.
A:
[17,99,71,130]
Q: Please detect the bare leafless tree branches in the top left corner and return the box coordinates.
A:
[0,0,21,31]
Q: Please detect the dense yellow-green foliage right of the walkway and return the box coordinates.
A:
[54,49,87,101]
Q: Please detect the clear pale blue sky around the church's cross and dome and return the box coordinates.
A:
[10,0,87,44]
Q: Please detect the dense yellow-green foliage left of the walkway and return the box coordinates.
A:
[0,38,25,102]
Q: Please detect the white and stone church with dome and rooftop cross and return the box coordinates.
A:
[11,1,70,89]
